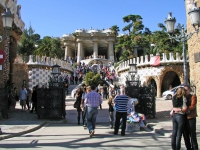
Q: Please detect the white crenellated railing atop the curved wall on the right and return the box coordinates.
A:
[116,53,188,72]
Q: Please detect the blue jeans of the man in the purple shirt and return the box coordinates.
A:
[87,107,98,133]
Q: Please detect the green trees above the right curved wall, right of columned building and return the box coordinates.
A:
[115,15,187,61]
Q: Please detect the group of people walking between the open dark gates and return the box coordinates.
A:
[75,84,147,137]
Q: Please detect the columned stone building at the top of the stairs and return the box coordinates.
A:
[61,28,116,62]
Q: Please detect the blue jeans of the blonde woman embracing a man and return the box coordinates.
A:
[171,113,186,150]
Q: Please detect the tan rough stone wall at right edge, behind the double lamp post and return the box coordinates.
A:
[185,0,200,119]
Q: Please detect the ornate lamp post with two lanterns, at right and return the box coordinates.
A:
[165,3,200,85]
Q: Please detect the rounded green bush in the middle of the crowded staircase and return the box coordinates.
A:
[85,72,102,86]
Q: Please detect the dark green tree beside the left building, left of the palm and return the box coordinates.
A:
[18,26,40,60]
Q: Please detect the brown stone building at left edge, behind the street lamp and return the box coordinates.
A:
[0,0,25,88]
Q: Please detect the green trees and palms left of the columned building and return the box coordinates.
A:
[18,26,64,59]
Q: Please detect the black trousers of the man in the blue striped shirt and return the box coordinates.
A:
[114,112,127,135]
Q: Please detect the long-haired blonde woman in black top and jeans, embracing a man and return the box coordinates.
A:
[171,87,187,150]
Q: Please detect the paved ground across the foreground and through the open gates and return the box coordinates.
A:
[0,95,200,150]
